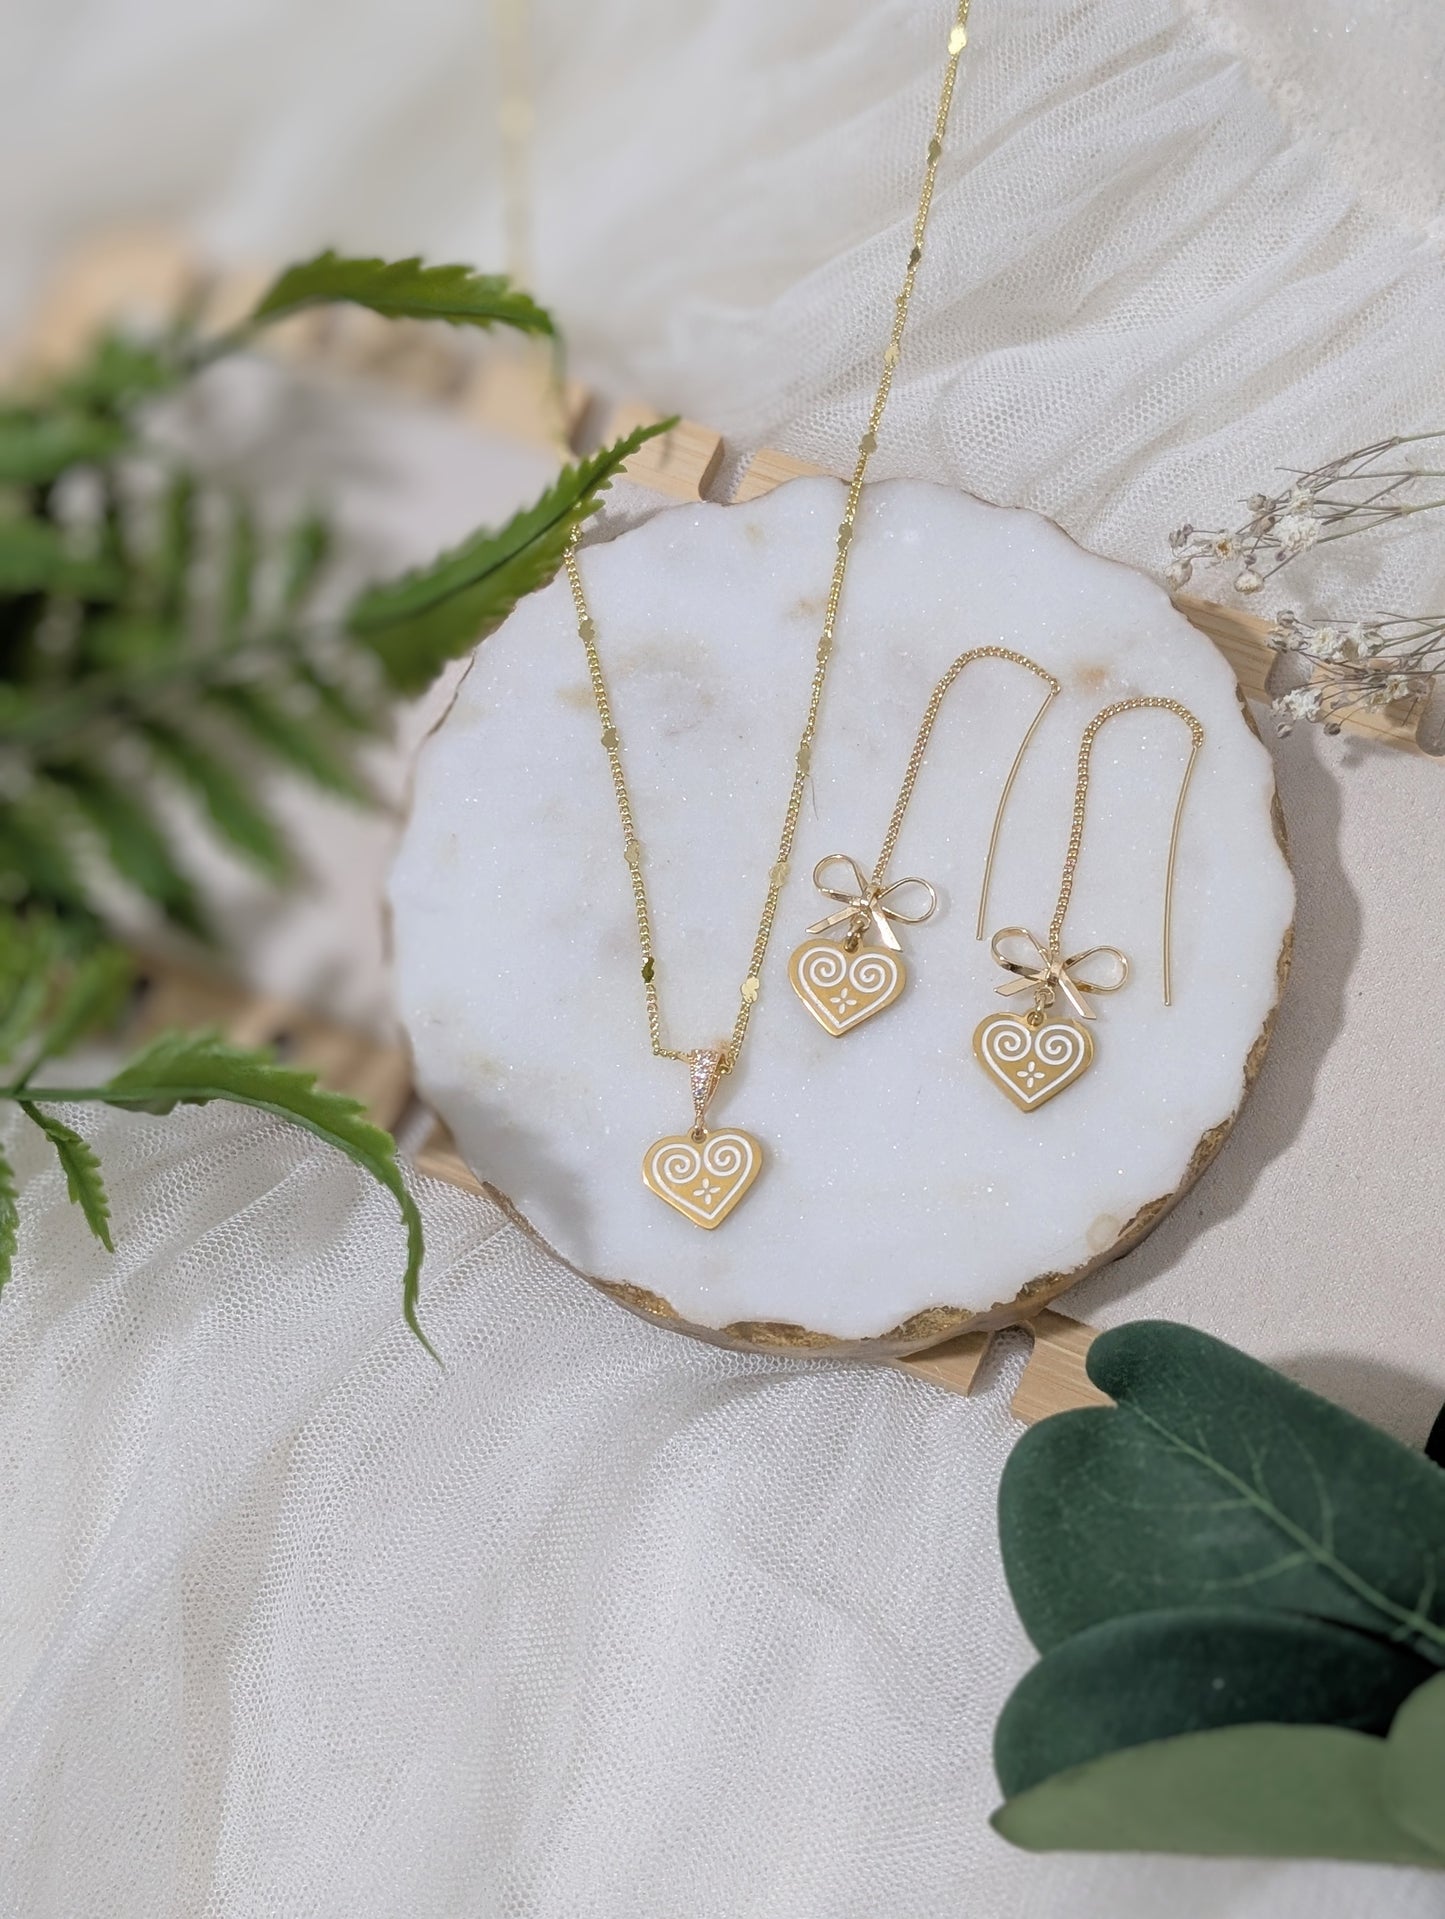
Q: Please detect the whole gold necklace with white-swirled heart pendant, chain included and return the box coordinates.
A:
[566,0,969,1228]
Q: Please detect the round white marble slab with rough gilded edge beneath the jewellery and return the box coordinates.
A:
[391,480,1293,1343]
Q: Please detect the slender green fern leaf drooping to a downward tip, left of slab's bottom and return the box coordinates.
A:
[94,1032,436,1357]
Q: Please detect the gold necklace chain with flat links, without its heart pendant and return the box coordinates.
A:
[566,0,969,1073]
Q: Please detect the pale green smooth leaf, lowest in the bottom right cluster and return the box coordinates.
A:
[992,1725,1445,1867]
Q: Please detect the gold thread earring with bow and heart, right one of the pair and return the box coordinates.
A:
[973,697,1205,1113]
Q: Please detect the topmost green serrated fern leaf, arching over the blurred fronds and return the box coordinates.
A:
[249,251,553,334]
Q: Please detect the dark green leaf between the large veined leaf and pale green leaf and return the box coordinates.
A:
[994,1608,1435,1798]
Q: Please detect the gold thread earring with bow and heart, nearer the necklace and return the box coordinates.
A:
[787,647,1059,1040]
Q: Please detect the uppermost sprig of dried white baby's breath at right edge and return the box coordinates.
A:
[1165,428,1445,593]
